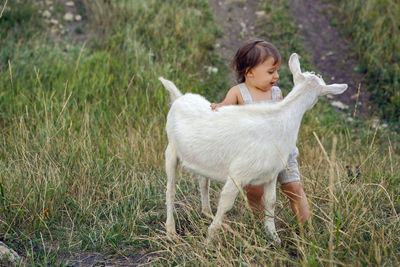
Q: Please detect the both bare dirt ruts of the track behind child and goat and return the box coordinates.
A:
[209,0,372,116]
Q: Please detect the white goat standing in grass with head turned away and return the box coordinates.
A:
[159,54,347,243]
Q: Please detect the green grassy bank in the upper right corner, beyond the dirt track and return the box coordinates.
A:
[331,0,400,123]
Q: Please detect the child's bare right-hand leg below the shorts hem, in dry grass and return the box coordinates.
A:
[281,181,311,226]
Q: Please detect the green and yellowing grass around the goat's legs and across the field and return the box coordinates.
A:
[0,0,400,266]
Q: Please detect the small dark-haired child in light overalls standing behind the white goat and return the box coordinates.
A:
[211,40,311,225]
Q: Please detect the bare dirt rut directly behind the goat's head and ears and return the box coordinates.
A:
[290,0,373,116]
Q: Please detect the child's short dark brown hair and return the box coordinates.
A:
[232,40,282,83]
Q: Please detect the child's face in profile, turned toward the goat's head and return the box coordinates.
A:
[246,57,281,91]
